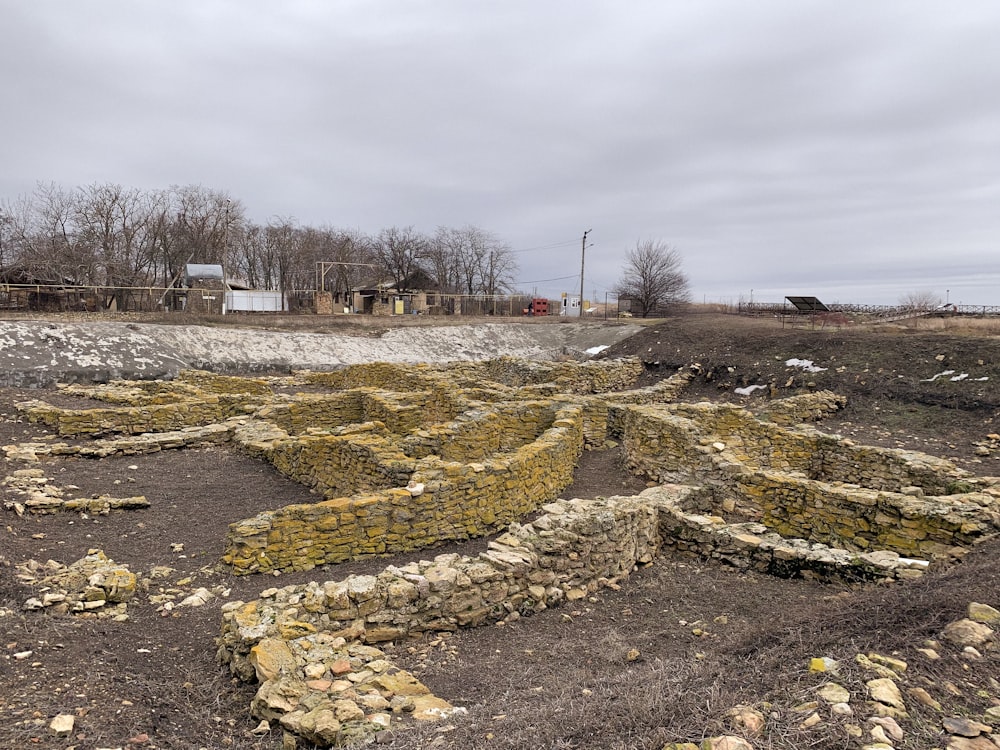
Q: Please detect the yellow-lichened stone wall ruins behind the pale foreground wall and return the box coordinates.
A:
[18,358,997,588]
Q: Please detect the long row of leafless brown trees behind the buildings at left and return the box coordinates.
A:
[0,183,517,295]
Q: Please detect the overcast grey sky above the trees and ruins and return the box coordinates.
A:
[0,0,1000,305]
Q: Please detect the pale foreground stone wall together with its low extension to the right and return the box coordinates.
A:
[219,485,936,744]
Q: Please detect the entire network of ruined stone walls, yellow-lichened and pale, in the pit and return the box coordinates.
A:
[6,358,1000,747]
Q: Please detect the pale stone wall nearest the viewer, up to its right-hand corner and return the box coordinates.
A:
[221,490,672,678]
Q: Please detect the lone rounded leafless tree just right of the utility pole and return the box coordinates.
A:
[615,240,691,318]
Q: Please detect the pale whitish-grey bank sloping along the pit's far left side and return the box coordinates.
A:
[0,320,640,388]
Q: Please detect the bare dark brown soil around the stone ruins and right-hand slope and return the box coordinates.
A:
[0,316,1000,750]
